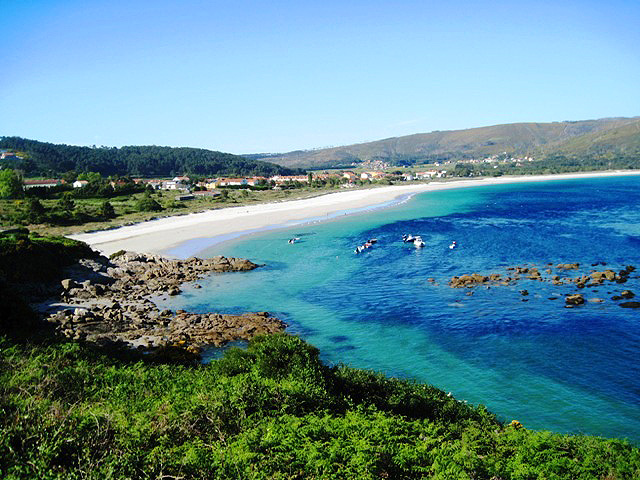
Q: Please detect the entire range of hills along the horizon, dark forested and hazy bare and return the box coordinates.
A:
[5,117,640,176]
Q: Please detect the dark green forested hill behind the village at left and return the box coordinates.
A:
[0,137,298,177]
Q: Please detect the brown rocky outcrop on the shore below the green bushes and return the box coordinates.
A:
[46,252,285,352]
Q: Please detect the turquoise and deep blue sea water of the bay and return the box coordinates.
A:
[162,177,640,444]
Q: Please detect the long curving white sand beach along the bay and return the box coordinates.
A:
[70,171,640,255]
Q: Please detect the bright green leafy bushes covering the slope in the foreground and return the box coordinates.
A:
[0,334,640,479]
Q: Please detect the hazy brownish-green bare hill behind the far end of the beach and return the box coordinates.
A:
[249,117,640,168]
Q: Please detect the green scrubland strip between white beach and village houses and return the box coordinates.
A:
[0,170,360,234]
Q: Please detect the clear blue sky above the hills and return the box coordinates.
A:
[0,0,640,153]
